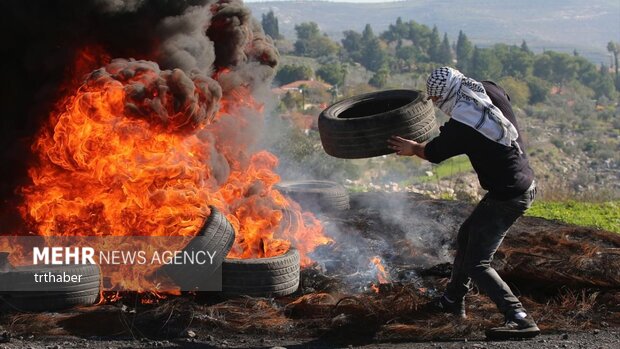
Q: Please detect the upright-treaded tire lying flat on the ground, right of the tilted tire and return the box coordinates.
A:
[222,247,300,297]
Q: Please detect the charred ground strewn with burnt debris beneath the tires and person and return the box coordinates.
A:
[0,193,620,348]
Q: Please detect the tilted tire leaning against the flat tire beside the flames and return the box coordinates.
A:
[162,206,235,290]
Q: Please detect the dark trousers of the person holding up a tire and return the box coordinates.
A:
[446,183,536,317]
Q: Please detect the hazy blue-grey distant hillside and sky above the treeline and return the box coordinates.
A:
[247,0,620,64]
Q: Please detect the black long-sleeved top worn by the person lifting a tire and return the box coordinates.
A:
[424,81,534,200]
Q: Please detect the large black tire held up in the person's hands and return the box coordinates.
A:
[319,90,437,159]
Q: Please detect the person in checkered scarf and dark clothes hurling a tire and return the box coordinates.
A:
[388,67,540,339]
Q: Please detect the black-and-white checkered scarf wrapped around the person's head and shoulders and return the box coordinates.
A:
[426,67,522,153]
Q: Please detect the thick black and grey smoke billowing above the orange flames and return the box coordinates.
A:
[0,0,278,223]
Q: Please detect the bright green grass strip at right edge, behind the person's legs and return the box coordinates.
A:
[526,201,620,233]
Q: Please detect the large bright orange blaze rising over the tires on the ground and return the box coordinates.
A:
[5,54,330,290]
